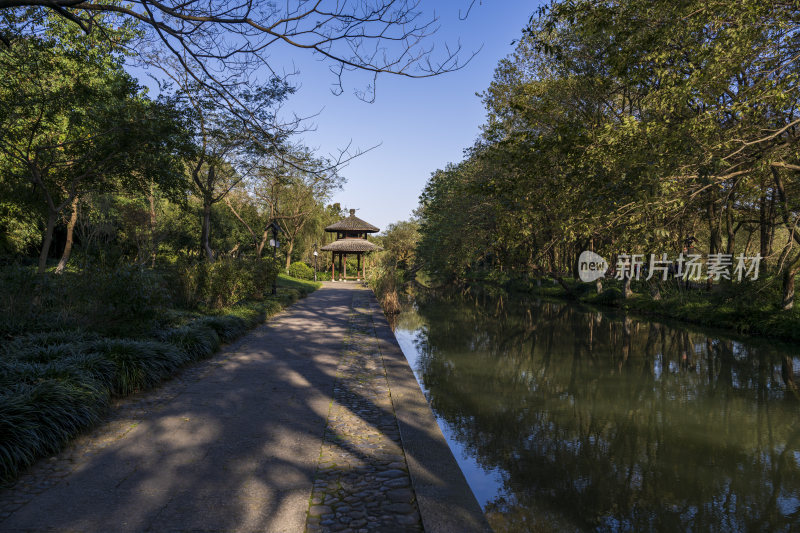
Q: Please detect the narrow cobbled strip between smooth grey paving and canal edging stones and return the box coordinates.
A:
[306,292,422,533]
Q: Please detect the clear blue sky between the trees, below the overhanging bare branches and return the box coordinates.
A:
[262,0,542,229]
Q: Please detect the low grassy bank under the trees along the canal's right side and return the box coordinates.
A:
[507,279,800,342]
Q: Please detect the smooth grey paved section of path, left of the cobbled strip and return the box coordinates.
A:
[0,286,352,533]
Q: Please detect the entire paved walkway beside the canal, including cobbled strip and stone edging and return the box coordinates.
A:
[0,283,485,532]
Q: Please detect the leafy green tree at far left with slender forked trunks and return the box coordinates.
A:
[0,14,187,272]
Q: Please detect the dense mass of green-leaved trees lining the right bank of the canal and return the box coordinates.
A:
[416,0,800,316]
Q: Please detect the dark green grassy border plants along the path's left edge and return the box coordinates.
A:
[0,278,319,486]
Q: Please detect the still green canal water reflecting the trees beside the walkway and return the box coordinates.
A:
[397,300,800,532]
